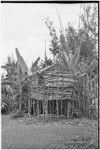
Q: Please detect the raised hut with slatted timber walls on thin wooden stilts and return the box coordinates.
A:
[29,62,78,118]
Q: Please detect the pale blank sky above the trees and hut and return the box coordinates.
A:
[0,3,81,74]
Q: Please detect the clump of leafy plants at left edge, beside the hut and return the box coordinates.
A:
[1,57,27,113]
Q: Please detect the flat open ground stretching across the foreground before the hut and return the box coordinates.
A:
[1,115,98,149]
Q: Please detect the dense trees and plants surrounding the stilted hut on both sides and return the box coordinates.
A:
[1,3,98,117]
